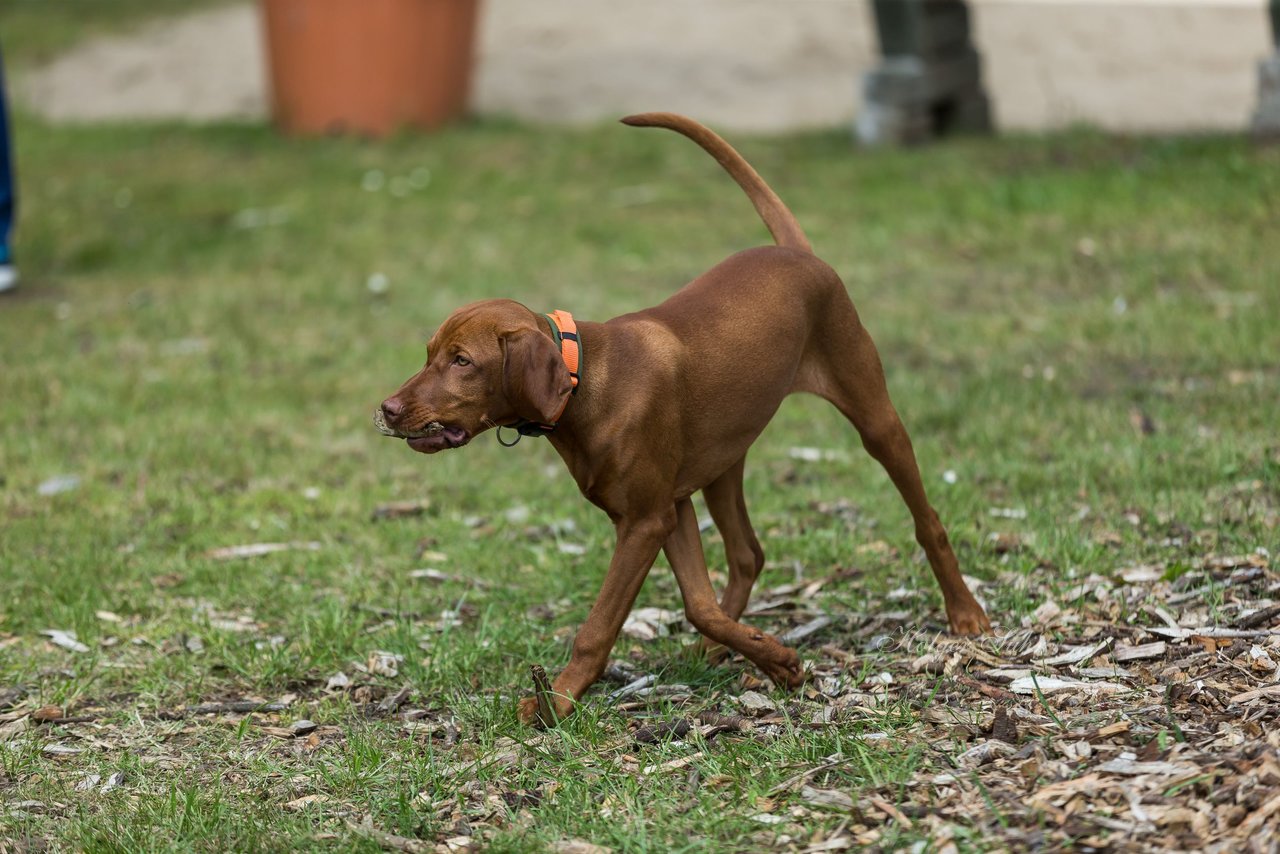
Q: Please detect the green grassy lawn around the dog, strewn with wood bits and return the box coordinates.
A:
[0,4,1280,851]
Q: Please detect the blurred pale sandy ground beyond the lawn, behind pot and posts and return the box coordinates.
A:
[19,0,1271,131]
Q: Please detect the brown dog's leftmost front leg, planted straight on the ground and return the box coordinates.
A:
[518,508,676,726]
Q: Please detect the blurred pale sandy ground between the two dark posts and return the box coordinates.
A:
[972,0,1271,131]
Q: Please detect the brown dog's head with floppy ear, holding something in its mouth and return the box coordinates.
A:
[374,300,572,453]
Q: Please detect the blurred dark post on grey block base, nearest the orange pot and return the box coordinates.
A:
[855,0,991,145]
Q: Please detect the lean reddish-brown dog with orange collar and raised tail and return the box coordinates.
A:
[374,113,991,725]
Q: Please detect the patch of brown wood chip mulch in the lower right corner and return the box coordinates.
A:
[744,552,1280,851]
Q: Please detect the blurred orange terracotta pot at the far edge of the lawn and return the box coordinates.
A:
[261,0,479,136]
